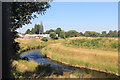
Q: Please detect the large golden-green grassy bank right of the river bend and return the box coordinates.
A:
[42,38,118,74]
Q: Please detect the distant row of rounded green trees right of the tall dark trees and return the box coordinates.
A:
[43,28,120,38]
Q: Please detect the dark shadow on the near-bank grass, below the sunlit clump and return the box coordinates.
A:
[12,65,63,79]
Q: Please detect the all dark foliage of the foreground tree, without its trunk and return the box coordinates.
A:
[6,2,50,56]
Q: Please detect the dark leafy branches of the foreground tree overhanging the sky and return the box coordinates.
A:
[10,2,50,31]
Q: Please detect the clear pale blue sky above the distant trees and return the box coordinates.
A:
[17,2,118,33]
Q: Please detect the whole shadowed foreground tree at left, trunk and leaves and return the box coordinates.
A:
[2,2,50,79]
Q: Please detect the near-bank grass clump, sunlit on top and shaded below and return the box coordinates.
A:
[12,60,63,79]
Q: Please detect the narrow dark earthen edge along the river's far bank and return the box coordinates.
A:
[20,47,120,77]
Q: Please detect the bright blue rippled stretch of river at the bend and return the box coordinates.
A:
[21,51,73,73]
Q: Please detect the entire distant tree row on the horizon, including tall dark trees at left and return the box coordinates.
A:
[25,25,120,38]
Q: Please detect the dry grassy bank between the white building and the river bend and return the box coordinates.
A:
[15,39,65,53]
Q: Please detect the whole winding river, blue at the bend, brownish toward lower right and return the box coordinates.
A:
[20,50,118,78]
